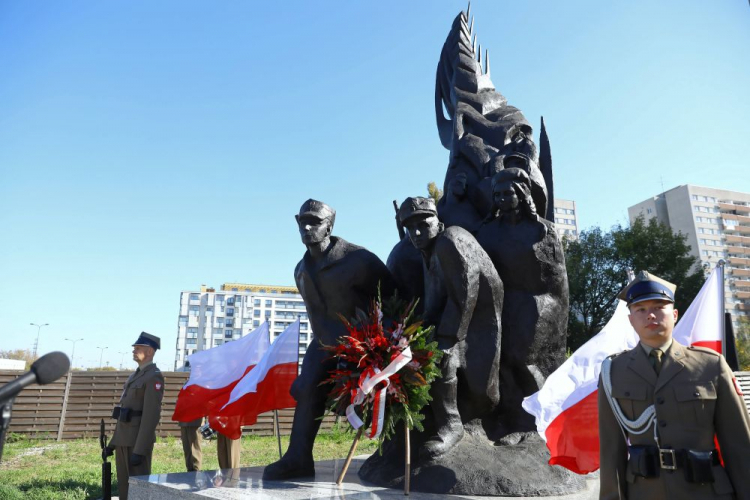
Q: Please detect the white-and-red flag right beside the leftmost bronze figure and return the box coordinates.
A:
[216,319,300,439]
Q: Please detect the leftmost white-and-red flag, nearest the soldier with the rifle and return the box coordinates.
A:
[172,322,271,422]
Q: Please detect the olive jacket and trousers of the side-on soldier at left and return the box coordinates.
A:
[109,363,164,500]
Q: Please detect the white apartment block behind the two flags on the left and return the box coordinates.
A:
[174,283,312,370]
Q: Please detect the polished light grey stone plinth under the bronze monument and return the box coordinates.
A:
[128,457,599,500]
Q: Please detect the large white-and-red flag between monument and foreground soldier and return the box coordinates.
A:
[522,301,638,474]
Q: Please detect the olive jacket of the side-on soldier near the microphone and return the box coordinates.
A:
[109,364,164,455]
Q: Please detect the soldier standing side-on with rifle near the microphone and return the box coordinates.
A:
[102,332,164,500]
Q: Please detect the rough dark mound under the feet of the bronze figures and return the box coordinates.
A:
[359,432,593,498]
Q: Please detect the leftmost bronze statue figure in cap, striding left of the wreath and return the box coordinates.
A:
[263,199,402,479]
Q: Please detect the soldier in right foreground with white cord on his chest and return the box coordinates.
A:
[598,272,750,500]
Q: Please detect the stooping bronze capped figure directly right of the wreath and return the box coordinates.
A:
[398,197,503,458]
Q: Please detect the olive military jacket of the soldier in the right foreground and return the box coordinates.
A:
[598,341,750,500]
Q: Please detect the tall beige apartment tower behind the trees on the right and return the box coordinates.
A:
[628,184,750,321]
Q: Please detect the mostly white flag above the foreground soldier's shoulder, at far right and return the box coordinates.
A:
[672,266,724,354]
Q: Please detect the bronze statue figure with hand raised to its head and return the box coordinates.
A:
[477,168,568,439]
